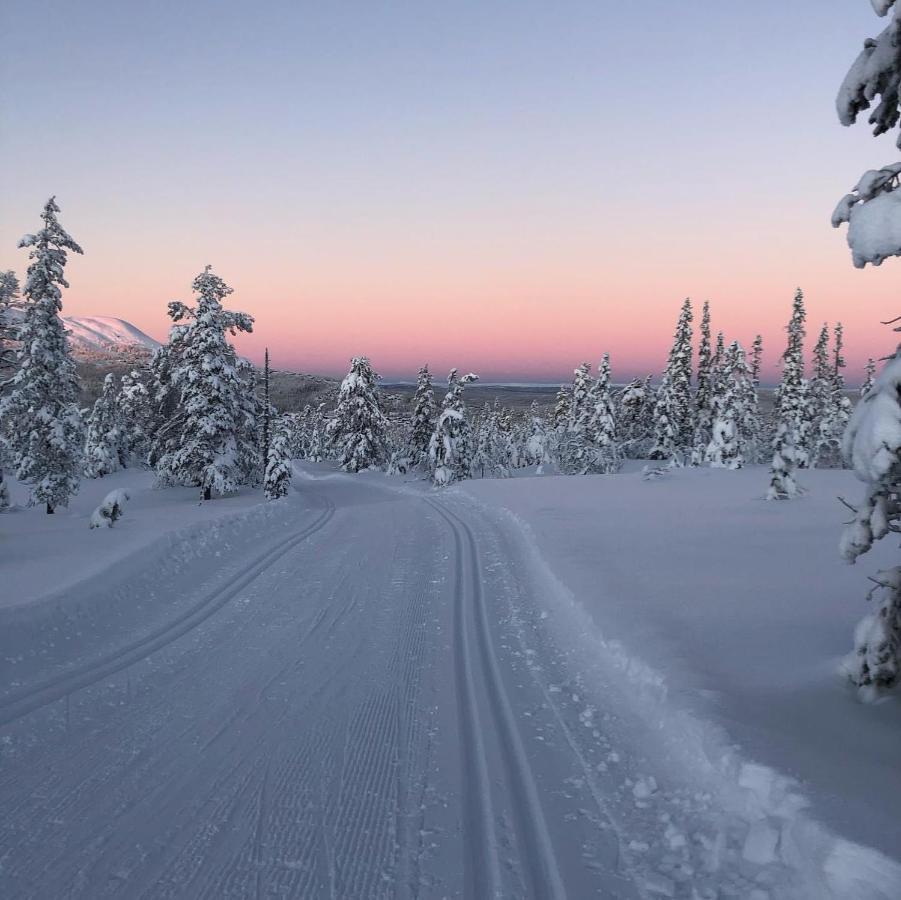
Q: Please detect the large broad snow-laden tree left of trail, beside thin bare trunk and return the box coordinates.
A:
[156,266,259,500]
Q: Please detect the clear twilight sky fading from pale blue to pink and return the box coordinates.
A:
[0,0,901,382]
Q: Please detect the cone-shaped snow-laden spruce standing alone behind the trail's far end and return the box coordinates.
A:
[327,356,390,472]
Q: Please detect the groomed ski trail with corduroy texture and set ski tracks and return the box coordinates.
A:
[0,475,892,900]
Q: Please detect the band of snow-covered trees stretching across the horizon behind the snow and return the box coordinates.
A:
[0,198,873,512]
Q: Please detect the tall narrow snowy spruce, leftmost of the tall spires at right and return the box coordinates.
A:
[650,298,694,464]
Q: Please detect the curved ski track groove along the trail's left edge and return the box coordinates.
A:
[0,504,335,728]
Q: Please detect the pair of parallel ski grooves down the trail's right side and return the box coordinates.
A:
[426,500,566,900]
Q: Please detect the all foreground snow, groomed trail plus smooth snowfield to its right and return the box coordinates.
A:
[0,466,901,900]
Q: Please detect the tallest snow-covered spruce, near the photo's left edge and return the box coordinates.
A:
[0,197,84,513]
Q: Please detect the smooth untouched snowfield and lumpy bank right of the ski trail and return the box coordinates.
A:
[462,468,901,900]
